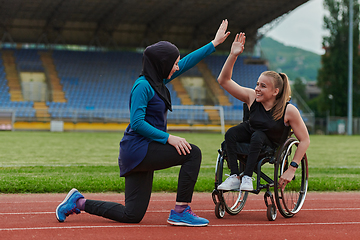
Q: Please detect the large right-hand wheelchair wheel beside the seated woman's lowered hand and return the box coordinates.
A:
[274,138,308,218]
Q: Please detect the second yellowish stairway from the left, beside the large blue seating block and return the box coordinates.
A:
[40,52,66,102]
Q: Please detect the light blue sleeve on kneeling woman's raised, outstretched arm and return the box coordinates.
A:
[164,42,215,84]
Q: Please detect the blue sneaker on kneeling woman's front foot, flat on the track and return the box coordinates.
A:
[167,206,209,227]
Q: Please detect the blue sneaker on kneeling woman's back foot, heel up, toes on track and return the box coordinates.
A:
[56,188,84,222]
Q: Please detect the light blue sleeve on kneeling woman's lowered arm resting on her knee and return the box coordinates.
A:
[130,79,169,144]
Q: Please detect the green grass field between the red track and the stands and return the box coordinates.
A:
[0,132,360,193]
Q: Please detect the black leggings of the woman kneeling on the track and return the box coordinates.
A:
[85,142,201,223]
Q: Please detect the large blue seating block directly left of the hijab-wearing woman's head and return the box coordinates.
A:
[48,51,141,118]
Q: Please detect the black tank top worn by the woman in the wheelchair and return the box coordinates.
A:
[248,100,289,145]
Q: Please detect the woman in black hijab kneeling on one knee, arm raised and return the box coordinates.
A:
[56,20,230,226]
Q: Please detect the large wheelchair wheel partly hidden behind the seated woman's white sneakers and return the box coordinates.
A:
[216,154,248,215]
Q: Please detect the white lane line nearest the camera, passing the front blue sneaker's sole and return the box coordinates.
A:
[0,222,360,231]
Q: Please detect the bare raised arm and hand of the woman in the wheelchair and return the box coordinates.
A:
[218,33,256,106]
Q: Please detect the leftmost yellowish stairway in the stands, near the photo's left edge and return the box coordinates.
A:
[2,50,24,101]
